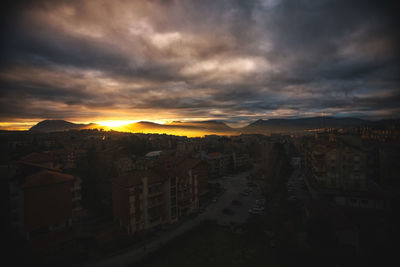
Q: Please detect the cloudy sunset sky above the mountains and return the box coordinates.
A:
[0,0,400,129]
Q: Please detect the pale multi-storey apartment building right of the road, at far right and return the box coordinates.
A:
[304,137,385,209]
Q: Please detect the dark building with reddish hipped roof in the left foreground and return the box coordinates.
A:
[10,169,81,240]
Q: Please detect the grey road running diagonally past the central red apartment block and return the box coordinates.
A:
[87,167,261,267]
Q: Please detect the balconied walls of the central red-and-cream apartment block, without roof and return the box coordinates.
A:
[112,170,200,233]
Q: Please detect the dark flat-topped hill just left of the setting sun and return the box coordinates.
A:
[29,120,96,133]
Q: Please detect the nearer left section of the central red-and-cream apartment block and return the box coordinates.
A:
[112,170,176,236]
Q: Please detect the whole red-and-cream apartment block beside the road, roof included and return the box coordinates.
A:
[112,158,207,233]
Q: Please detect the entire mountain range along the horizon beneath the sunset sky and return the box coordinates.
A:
[29,117,399,136]
